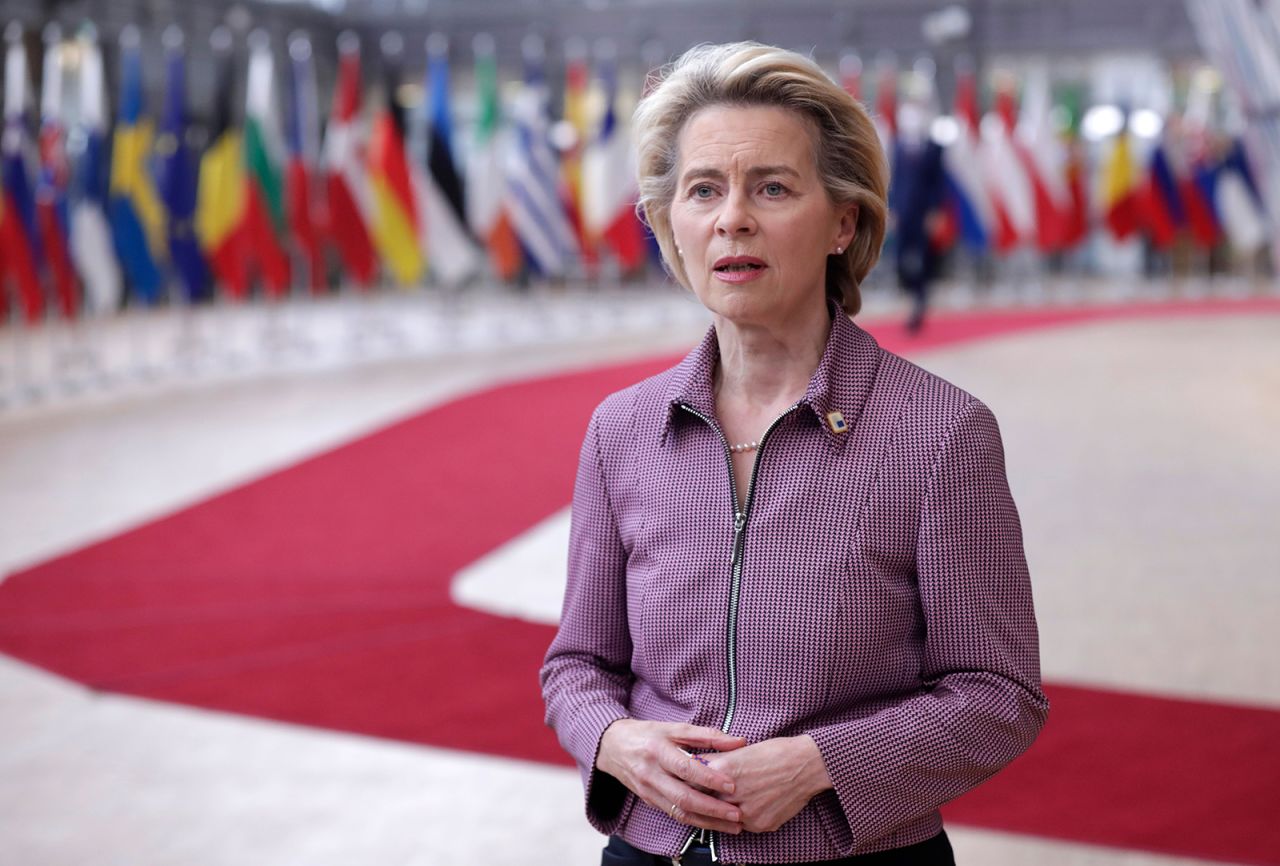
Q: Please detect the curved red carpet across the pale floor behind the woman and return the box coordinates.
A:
[0,299,1280,865]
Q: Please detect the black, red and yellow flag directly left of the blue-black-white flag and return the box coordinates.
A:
[369,33,426,285]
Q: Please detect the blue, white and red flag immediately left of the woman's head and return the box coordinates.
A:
[582,43,648,271]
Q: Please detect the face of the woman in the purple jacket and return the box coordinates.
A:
[671,106,858,325]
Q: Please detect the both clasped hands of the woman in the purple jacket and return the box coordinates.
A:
[595,719,831,834]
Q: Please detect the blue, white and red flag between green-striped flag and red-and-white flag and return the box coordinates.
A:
[284,32,325,294]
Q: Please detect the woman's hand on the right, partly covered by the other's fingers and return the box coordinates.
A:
[708,736,831,833]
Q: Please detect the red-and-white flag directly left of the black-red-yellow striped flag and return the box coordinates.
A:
[324,31,378,288]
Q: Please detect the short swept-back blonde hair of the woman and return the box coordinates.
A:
[632,42,888,315]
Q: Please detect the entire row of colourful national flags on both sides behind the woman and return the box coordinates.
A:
[0,24,1274,322]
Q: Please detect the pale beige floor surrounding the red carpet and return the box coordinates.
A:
[0,281,1280,866]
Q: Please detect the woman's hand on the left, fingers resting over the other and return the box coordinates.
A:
[595,719,747,833]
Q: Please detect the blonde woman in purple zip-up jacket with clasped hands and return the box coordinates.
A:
[541,43,1047,863]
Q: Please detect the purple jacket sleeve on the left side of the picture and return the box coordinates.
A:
[540,409,634,834]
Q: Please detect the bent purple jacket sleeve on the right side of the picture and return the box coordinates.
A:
[808,398,1048,852]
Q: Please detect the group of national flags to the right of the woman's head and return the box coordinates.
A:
[842,61,1271,263]
